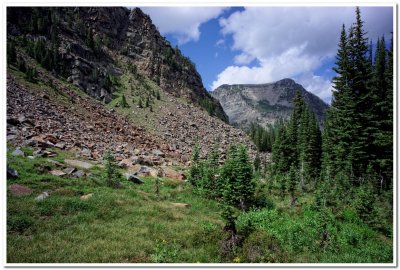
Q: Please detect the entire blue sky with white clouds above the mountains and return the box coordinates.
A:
[142,6,393,103]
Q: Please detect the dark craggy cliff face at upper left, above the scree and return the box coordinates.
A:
[7,7,227,121]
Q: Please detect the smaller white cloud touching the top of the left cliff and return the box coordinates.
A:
[142,7,225,45]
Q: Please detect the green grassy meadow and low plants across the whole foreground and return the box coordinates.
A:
[7,145,393,263]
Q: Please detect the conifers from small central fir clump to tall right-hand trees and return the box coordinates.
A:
[189,8,393,238]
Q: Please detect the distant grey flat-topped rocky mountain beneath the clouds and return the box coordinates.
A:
[211,79,328,127]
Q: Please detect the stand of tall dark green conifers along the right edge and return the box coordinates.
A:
[270,8,393,234]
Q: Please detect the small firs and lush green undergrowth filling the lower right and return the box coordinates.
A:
[189,139,393,263]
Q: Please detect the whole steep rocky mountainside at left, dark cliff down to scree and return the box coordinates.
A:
[7,8,255,166]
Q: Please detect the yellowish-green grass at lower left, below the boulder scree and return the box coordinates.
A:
[7,146,223,263]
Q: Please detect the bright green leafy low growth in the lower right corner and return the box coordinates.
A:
[237,195,393,263]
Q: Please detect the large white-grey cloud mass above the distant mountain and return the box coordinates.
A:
[212,7,393,101]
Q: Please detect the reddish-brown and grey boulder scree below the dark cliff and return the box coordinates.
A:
[7,72,255,173]
